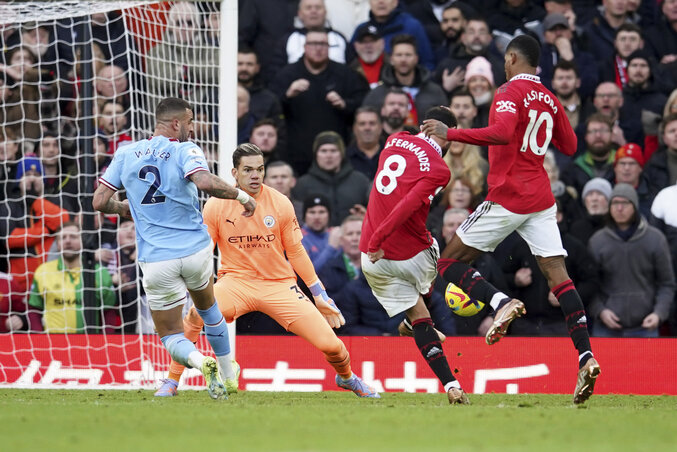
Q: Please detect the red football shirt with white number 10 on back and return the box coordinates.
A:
[447,74,576,214]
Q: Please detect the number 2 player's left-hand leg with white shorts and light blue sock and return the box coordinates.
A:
[141,259,225,398]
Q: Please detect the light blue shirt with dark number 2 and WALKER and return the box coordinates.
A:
[99,136,211,262]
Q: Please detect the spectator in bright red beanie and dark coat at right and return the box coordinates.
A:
[614,143,655,218]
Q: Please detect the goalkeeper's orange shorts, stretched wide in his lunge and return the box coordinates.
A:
[214,274,325,330]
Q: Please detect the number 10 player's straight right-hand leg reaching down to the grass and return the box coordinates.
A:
[517,205,600,403]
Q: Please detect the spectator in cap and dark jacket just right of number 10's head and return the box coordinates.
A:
[539,13,598,99]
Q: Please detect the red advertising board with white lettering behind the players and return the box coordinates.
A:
[0,334,677,395]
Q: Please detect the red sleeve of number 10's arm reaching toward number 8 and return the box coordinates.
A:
[447,87,519,146]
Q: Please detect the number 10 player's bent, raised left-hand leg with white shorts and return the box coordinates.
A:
[437,201,526,345]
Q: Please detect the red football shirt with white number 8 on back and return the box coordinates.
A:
[360,132,451,261]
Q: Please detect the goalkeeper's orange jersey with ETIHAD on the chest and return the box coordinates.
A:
[203,184,303,280]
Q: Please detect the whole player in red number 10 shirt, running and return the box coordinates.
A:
[421,35,600,403]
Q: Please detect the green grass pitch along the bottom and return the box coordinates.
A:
[0,389,677,452]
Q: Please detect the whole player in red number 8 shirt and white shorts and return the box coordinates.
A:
[360,107,469,404]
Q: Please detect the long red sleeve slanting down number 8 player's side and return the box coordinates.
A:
[368,170,449,253]
